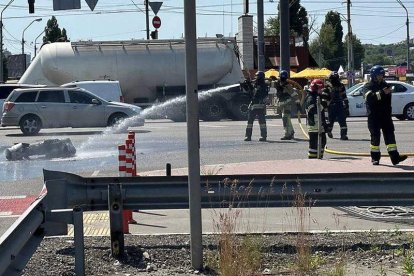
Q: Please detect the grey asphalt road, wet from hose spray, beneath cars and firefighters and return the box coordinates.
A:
[0,118,414,236]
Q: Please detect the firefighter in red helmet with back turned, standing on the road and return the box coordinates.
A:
[304,79,327,159]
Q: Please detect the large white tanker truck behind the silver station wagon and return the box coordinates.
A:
[19,39,249,121]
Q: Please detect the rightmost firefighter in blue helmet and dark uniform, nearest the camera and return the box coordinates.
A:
[362,65,407,165]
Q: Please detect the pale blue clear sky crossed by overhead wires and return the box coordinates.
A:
[0,0,414,57]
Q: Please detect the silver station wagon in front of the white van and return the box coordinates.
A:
[1,87,144,135]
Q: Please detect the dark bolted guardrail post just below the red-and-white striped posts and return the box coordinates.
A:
[108,184,124,259]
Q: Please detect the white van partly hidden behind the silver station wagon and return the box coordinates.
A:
[61,80,124,102]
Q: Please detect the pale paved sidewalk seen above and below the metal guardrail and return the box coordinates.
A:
[69,157,414,235]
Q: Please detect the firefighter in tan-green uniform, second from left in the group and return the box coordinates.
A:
[275,70,301,140]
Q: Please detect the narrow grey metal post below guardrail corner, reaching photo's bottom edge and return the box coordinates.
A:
[73,207,85,276]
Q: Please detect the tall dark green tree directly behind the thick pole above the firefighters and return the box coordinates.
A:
[265,0,309,45]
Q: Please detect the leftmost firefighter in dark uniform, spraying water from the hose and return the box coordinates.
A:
[244,71,269,142]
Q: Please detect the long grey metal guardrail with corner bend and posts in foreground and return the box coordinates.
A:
[0,170,414,275]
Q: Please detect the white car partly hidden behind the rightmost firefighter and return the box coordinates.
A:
[347,81,414,120]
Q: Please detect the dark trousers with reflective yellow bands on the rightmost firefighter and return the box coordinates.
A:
[368,116,400,163]
